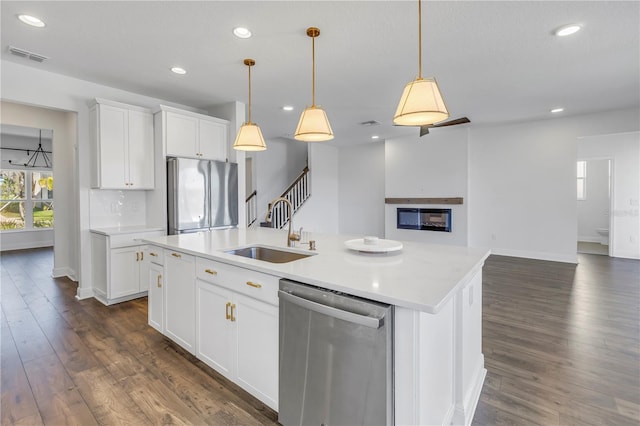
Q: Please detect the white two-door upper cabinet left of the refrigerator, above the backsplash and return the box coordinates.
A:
[89,99,154,189]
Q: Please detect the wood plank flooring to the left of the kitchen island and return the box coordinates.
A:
[0,249,277,425]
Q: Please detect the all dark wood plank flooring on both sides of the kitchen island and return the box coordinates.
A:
[0,249,640,426]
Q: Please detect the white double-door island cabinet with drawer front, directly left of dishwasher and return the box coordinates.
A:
[196,258,279,410]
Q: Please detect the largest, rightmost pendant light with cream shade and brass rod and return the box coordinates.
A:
[393,0,449,126]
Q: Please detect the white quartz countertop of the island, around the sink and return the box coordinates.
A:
[142,228,490,313]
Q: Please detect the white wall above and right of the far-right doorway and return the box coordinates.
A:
[578,132,640,259]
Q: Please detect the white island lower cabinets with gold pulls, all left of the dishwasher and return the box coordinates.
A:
[147,247,279,410]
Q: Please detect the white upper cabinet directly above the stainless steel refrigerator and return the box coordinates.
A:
[158,106,229,161]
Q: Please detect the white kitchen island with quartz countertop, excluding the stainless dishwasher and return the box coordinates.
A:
[143,228,489,425]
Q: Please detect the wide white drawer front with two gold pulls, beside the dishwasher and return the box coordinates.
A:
[196,257,280,306]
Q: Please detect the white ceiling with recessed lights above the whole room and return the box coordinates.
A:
[0,0,640,146]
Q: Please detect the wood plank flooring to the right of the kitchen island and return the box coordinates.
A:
[474,254,640,426]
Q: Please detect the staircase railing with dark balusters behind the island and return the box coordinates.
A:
[247,166,311,229]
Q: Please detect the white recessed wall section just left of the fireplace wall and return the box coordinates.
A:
[338,142,385,238]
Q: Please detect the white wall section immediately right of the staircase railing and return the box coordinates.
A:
[293,142,339,234]
